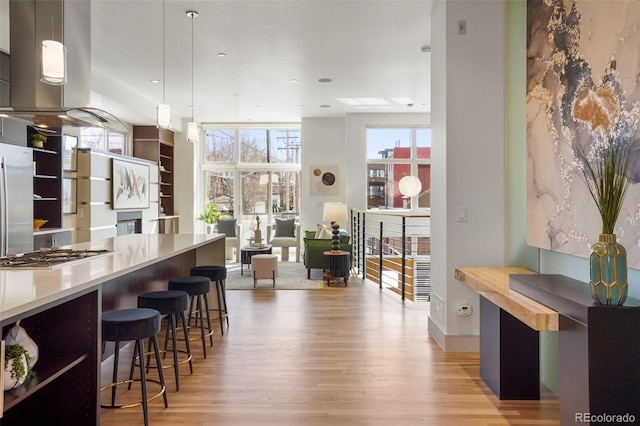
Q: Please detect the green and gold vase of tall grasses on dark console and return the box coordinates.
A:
[575,107,634,305]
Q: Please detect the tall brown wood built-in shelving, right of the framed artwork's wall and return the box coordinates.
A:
[133,126,174,216]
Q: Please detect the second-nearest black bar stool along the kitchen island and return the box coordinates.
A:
[138,290,193,391]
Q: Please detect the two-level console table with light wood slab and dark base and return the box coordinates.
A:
[455,268,640,425]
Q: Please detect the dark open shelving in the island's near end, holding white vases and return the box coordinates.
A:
[1,289,100,426]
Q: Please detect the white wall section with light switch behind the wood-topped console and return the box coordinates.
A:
[429,0,506,351]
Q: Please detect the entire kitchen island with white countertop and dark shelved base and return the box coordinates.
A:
[0,234,225,426]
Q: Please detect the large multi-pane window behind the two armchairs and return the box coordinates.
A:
[201,125,301,239]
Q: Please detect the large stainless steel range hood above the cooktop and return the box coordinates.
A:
[0,0,126,133]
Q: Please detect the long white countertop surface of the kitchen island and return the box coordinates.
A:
[0,234,224,321]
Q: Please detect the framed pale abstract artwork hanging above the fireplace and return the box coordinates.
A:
[111,158,150,210]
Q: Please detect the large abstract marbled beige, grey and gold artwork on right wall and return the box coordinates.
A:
[527,0,640,269]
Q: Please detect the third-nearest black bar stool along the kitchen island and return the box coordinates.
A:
[169,276,213,358]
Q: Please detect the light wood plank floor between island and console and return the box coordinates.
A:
[101,278,559,426]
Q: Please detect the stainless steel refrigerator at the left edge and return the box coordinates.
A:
[0,144,33,256]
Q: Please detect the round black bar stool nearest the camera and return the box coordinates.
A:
[100,308,169,426]
